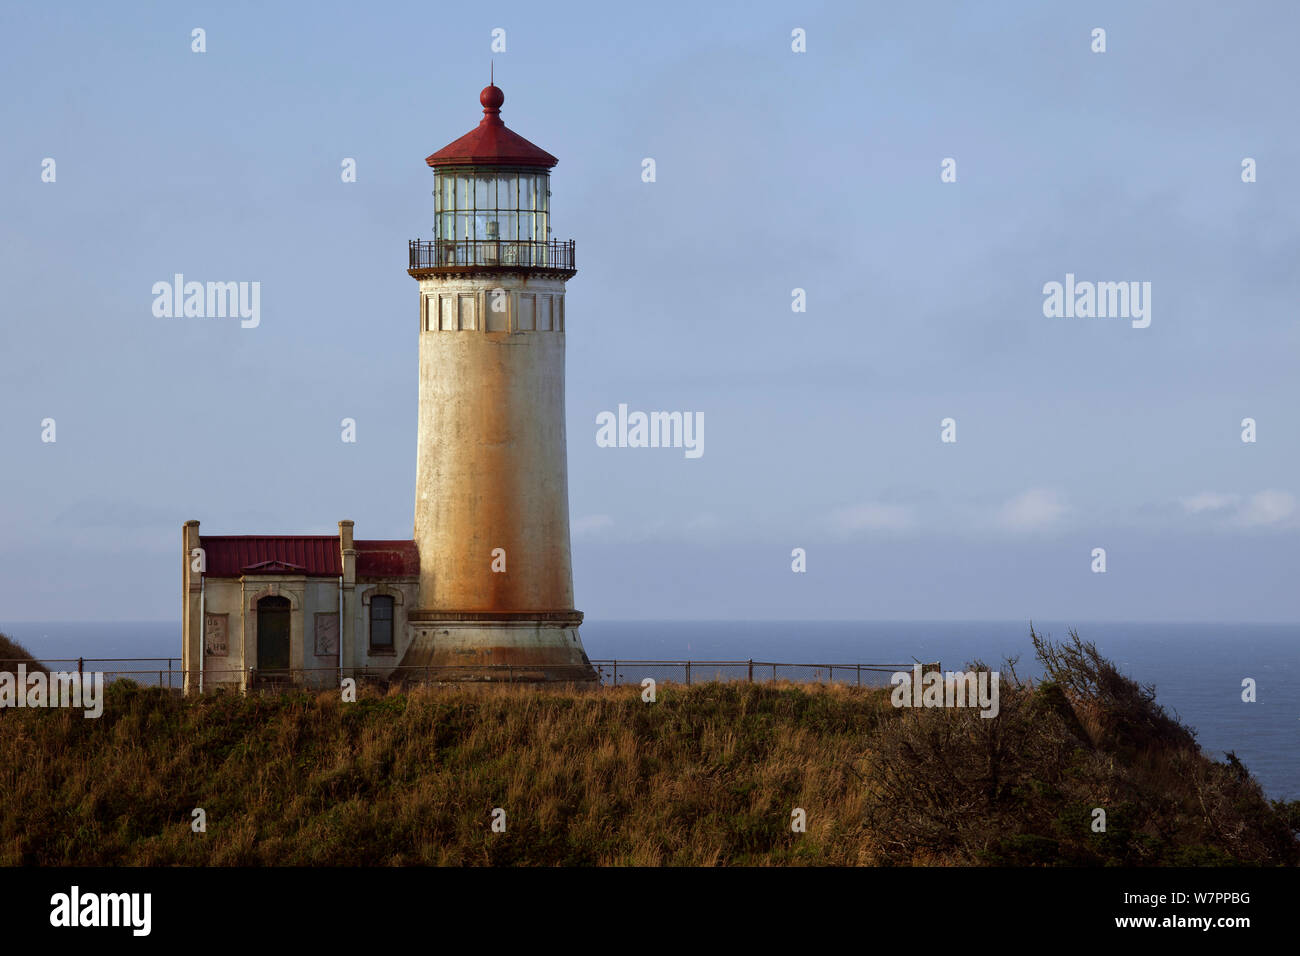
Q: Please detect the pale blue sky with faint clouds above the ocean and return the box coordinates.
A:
[0,3,1300,622]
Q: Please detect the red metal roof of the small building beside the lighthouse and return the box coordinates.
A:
[199,535,420,578]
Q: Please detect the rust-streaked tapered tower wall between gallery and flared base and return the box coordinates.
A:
[415,274,573,613]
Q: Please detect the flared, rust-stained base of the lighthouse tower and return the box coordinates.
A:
[393,611,599,685]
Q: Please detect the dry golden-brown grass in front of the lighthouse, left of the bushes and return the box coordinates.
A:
[0,685,881,865]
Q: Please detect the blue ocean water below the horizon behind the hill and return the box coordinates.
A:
[0,620,1300,800]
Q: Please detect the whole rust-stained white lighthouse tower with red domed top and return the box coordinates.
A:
[400,85,595,682]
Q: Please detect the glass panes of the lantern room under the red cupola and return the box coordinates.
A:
[433,166,551,242]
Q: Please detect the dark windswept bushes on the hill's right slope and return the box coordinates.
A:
[866,627,1300,866]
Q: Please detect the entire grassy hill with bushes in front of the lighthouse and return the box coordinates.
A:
[0,635,1300,865]
